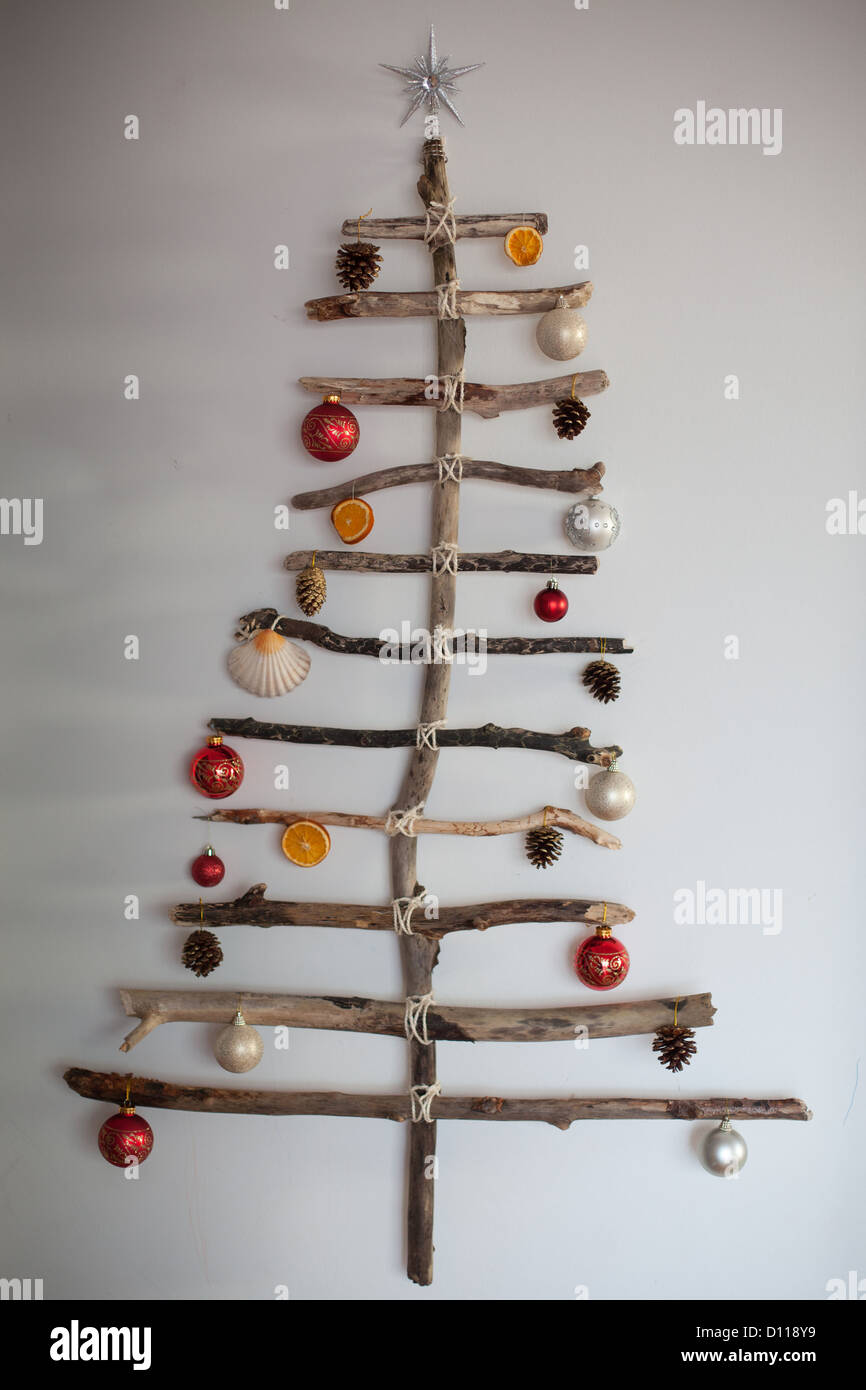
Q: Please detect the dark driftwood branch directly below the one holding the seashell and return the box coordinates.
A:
[207,719,623,772]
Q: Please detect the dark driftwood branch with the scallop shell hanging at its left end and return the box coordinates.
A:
[236,609,634,666]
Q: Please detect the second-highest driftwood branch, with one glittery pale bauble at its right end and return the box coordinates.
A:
[304,279,592,324]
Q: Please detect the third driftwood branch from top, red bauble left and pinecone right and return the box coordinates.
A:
[300,368,610,420]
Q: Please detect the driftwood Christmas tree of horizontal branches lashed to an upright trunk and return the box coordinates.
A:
[65,39,809,1284]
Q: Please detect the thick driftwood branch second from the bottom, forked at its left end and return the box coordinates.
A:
[120,989,716,1050]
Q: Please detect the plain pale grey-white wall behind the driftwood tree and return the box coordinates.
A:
[0,0,866,1301]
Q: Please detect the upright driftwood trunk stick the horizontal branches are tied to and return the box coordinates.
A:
[391,139,466,1284]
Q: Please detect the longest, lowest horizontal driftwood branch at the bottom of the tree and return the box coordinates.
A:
[63,1066,812,1130]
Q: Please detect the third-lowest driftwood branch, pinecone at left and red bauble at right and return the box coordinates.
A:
[168,883,634,940]
